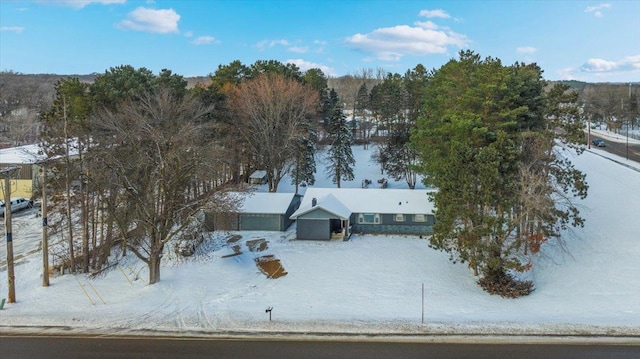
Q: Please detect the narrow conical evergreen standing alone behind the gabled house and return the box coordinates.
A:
[326,90,356,188]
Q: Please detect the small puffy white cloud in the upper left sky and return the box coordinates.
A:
[117,7,180,34]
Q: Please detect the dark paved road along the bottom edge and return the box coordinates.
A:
[0,336,640,359]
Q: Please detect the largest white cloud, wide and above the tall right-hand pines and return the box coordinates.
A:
[346,21,468,61]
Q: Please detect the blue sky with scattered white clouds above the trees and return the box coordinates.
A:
[0,0,640,82]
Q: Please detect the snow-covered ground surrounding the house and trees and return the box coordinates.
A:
[0,147,640,336]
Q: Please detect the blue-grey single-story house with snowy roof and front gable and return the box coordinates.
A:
[291,188,435,240]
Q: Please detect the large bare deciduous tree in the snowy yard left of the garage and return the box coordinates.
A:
[93,88,228,284]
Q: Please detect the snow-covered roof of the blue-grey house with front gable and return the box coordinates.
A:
[294,187,435,215]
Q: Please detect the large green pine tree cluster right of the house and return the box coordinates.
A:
[412,51,587,297]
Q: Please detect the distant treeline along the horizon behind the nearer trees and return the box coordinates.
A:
[0,69,640,146]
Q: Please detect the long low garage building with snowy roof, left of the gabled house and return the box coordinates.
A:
[205,192,301,231]
